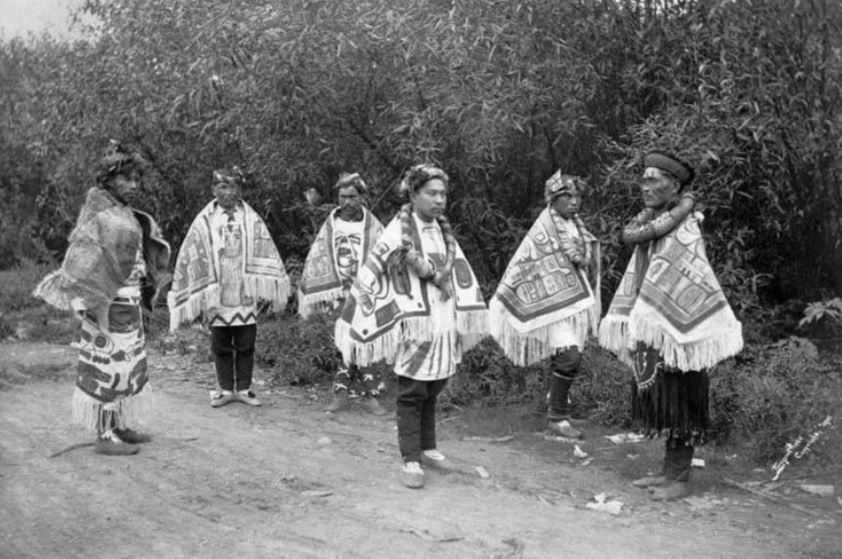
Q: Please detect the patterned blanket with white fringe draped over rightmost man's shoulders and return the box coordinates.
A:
[599,212,743,371]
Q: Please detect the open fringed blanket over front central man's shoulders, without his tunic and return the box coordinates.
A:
[335,214,488,366]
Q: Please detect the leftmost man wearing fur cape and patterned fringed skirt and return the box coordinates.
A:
[33,140,170,456]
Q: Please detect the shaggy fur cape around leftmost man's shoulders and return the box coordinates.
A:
[32,188,170,311]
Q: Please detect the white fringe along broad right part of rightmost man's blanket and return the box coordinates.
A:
[627,318,743,371]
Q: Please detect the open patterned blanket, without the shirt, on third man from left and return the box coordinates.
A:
[298,208,383,318]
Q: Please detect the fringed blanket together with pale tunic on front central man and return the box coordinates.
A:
[335,213,488,381]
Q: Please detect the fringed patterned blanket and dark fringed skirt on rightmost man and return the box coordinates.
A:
[599,212,743,440]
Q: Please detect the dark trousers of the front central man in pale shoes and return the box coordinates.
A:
[398,376,447,462]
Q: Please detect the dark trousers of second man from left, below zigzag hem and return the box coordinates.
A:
[211,324,257,391]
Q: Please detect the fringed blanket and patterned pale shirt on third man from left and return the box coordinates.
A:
[298,208,383,318]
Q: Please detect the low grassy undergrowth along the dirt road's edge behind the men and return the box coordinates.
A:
[0,260,842,470]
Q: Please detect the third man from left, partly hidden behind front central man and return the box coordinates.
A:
[298,173,387,415]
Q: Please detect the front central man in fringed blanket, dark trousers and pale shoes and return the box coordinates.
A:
[335,165,488,488]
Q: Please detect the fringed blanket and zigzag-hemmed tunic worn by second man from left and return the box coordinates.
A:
[167,200,290,330]
